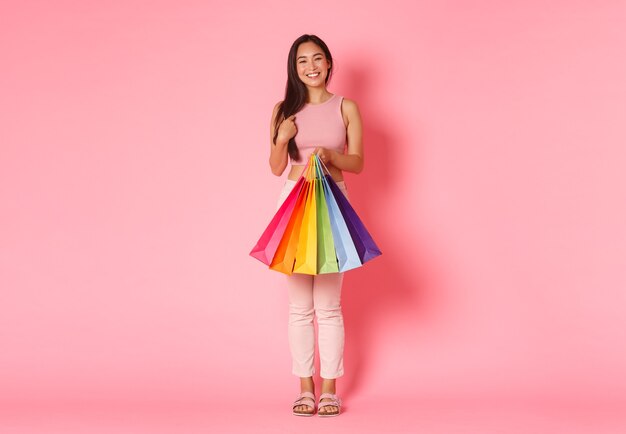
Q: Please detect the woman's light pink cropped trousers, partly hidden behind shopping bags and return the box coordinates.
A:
[276,179,348,379]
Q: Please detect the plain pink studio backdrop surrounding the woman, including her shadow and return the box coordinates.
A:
[0,0,626,433]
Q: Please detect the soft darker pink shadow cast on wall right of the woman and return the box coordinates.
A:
[332,53,438,396]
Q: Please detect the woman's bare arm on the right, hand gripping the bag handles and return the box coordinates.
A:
[317,98,364,173]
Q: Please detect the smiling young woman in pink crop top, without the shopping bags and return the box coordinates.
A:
[269,35,363,416]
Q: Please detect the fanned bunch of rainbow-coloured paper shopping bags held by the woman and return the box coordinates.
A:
[250,154,382,275]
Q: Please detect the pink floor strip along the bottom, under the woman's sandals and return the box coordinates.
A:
[0,396,626,434]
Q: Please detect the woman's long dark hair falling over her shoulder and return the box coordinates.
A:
[273,35,333,161]
